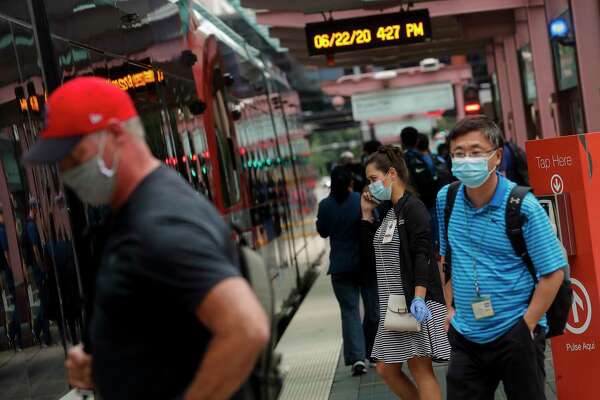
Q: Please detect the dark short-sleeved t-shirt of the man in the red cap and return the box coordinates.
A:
[91,167,240,400]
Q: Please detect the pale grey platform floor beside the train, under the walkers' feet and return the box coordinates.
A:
[277,253,557,400]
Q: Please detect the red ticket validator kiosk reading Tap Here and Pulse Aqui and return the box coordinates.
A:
[526,133,600,400]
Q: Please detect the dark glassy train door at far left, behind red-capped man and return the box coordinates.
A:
[0,18,83,399]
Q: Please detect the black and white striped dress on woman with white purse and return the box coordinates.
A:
[371,208,450,364]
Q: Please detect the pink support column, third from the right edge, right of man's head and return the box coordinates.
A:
[504,36,527,147]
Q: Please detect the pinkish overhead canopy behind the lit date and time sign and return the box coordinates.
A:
[241,0,531,66]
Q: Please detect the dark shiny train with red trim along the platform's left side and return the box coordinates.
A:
[0,0,323,399]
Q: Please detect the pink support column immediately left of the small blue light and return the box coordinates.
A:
[527,6,559,138]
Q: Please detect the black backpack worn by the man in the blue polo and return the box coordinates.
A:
[444,182,573,338]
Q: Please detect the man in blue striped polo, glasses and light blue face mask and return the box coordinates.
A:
[437,116,567,400]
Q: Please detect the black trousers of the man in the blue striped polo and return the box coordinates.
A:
[446,319,546,400]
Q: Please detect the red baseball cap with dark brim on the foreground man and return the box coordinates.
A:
[23,77,137,164]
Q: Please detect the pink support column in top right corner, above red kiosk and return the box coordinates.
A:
[571,0,600,132]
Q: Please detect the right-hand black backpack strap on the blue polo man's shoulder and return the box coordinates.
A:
[506,186,538,284]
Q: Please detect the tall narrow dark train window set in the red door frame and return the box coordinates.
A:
[213,68,241,208]
